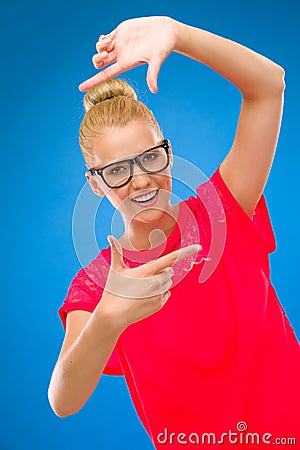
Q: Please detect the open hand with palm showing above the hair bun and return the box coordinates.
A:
[79,16,176,93]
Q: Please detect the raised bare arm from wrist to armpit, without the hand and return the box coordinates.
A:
[175,23,285,217]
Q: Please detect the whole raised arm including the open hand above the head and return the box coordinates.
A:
[80,17,285,216]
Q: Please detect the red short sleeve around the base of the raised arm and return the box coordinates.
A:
[197,167,276,253]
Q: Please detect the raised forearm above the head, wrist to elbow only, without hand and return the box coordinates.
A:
[173,21,284,99]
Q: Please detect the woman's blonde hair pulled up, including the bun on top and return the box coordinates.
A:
[79,78,162,168]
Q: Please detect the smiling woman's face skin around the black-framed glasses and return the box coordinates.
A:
[85,121,172,223]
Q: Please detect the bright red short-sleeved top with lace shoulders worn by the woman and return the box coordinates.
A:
[59,168,300,449]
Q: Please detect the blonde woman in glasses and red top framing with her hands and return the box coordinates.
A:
[49,17,300,448]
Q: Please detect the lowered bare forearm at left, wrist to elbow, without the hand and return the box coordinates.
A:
[48,296,121,417]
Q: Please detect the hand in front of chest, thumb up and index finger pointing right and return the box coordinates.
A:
[100,236,201,329]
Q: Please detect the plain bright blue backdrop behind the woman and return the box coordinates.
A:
[0,0,300,450]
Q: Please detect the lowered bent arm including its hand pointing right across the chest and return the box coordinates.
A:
[48,239,201,417]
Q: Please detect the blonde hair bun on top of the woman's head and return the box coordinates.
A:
[83,78,137,111]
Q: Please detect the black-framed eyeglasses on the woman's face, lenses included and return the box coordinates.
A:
[89,139,171,189]
